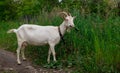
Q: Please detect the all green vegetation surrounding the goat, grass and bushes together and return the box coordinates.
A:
[0,0,120,73]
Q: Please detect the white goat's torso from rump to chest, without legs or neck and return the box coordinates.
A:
[17,24,60,45]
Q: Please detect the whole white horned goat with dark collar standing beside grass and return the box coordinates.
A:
[8,12,74,64]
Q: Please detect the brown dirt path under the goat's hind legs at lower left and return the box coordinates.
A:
[0,49,70,73]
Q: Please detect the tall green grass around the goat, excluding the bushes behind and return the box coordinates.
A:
[0,12,120,73]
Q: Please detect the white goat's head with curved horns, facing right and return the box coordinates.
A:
[60,12,75,28]
